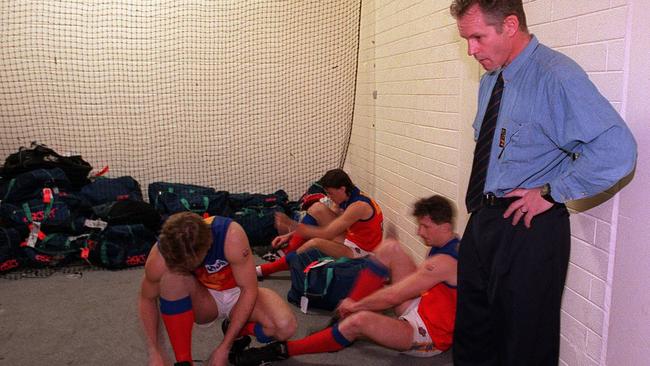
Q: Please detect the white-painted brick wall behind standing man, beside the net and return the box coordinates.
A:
[345,0,628,366]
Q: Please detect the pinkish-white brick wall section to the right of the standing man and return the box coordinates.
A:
[526,0,628,365]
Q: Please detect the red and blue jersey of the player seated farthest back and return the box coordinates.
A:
[339,188,384,252]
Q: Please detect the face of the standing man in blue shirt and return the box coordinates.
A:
[457,5,512,71]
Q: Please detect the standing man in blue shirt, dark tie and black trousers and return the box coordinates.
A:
[450,0,636,366]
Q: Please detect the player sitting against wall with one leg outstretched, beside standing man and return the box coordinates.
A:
[231,196,459,366]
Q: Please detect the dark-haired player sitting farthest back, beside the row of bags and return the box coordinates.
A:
[256,169,384,277]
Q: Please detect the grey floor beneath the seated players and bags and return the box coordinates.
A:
[0,268,452,366]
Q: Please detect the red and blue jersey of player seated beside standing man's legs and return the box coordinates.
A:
[418,238,459,351]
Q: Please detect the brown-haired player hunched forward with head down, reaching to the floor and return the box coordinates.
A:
[140,212,296,365]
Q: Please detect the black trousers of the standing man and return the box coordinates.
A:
[453,204,571,366]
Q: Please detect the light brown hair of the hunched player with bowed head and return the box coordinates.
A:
[158,211,212,273]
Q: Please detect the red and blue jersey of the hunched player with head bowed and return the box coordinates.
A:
[194,216,237,291]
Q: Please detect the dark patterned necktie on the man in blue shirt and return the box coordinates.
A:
[465,73,503,212]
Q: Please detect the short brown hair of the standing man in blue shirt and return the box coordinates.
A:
[449,0,528,33]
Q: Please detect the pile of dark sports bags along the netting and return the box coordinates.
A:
[0,143,298,273]
